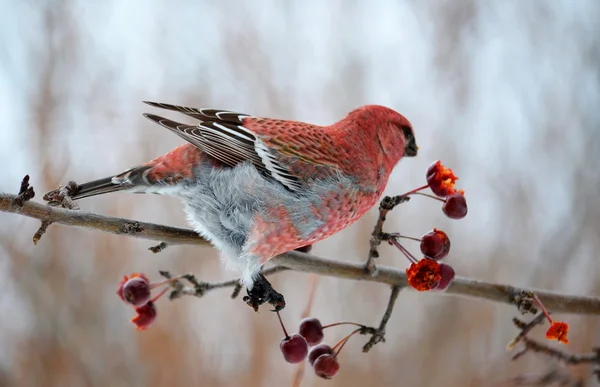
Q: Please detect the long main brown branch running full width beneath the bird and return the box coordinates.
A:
[0,193,600,315]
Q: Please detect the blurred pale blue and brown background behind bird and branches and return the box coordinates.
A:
[0,0,600,387]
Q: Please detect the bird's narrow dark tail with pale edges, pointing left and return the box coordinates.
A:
[43,166,150,205]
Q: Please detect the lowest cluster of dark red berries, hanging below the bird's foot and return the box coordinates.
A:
[277,312,365,379]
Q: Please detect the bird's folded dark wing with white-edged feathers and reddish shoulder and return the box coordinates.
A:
[144,101,332,191]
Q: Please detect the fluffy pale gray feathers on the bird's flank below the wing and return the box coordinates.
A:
[180,163,351,255]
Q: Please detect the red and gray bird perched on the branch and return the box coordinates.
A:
[44,101,418,310]
